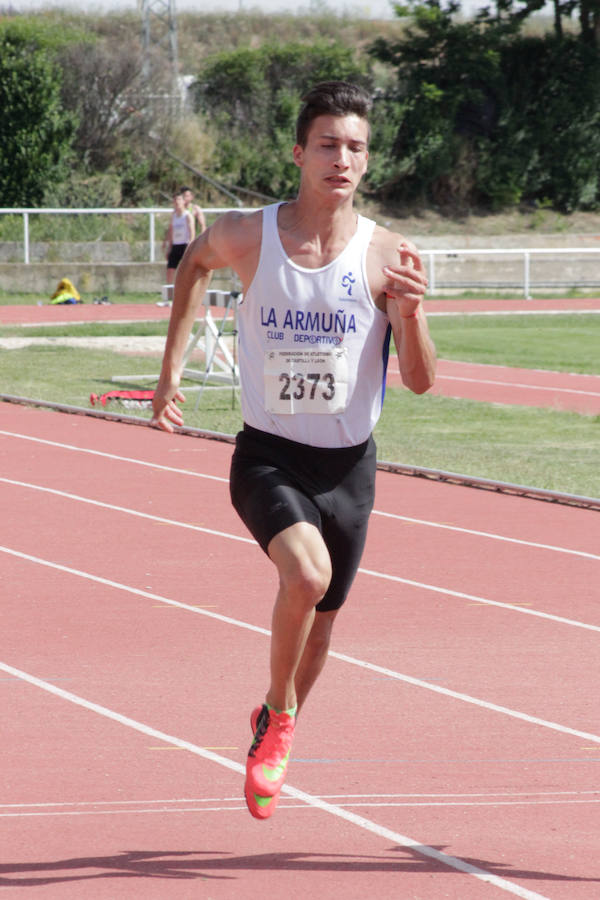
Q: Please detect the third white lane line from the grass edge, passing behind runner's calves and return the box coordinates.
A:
[0,546,600,753]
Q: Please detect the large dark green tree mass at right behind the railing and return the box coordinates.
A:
[370,0,600,212]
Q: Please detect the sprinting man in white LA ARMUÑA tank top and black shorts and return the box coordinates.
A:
[152,82,435,819]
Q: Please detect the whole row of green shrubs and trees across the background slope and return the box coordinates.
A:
[0,9,600,212]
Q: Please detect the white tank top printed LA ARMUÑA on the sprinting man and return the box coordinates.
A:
[238,204,390,447]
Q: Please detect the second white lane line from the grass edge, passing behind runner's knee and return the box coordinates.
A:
[0,477,600,632]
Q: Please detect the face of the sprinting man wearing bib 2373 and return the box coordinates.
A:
[294,115,369,197]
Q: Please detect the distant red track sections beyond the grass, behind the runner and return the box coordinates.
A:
[0,298,600,415]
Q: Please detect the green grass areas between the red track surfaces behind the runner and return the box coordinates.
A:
[0,306,600,497]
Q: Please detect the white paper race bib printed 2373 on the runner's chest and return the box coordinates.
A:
[264,347,348,415]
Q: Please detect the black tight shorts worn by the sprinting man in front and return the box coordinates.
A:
[230,425,376,612]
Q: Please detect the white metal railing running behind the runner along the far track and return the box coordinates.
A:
[0,206,600,300]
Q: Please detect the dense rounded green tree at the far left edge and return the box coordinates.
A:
[0,31,75,206]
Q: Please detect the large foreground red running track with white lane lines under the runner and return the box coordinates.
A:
[0,404,600,900]
